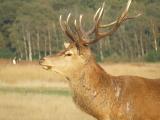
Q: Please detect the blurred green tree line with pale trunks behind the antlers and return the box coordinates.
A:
[0,0,160,61]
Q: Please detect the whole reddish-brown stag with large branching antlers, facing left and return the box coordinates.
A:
[40,0,160,120]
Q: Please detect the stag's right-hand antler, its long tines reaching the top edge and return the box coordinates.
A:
[83,0,141,44]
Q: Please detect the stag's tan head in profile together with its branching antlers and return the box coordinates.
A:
[40,0,140,77]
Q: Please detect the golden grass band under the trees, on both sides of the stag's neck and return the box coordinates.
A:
[0,63,160,84]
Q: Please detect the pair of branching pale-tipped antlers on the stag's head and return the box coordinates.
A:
[60,0,141,45]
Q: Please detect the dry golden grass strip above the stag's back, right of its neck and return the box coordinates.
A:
[102,63,160,79]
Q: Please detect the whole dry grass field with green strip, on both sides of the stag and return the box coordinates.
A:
[0,62,160,120]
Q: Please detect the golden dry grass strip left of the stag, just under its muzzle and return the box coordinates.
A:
[0,64,63,84]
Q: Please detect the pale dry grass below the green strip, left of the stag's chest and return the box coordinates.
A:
[0,92,94,120]
